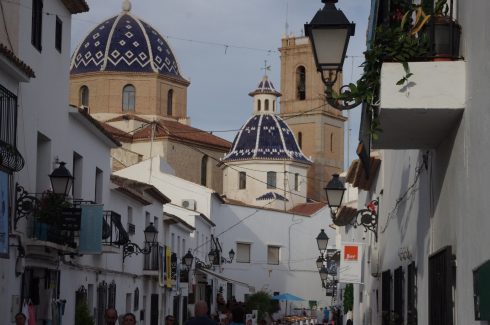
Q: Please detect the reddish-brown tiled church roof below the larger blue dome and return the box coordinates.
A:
[102,114,231,152]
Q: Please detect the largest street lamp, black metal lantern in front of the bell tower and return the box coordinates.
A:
[305,0,360,110]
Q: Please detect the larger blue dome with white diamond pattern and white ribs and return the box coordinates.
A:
[70,10,183,79]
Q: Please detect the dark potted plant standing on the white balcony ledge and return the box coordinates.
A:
[426,0,461,60]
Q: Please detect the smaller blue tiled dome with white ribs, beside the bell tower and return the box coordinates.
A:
[223,114,312,164]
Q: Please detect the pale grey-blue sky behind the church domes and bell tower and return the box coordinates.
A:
[71,0,371,166]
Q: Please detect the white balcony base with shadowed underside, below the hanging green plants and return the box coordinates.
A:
[373,61,466,149]
